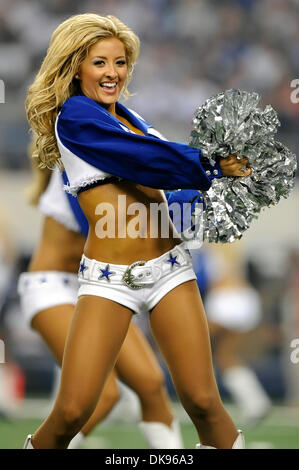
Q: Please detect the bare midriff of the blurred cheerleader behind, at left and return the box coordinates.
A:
[28,217,85,273]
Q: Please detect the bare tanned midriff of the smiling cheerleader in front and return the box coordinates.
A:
[78,110,181,265]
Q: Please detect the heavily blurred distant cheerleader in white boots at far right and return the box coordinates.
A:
[198,241,271,427]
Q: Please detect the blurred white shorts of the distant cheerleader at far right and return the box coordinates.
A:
[205,287,262,332]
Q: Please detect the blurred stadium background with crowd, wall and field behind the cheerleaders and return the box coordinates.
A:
[0,0,299,449]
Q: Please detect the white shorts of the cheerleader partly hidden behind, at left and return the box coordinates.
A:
[18,271,79,325]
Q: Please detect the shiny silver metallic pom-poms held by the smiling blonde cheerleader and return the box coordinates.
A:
[190,90,297,243]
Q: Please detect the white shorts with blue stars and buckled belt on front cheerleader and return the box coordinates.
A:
[78,244,196,313]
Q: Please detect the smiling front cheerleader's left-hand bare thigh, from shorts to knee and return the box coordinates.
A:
[58,295,132,406]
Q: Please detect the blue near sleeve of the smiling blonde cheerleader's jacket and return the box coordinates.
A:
[57,96,221,190]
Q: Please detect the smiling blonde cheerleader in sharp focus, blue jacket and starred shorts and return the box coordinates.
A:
[26,14,250,449]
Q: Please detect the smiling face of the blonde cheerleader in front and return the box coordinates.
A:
[76,38,127,114]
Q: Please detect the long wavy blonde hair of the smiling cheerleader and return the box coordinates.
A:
[25,13,140,169]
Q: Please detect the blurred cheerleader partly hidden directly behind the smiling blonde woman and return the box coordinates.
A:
[18,168,183,449]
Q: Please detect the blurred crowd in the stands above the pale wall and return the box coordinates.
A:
[0,0,299,168]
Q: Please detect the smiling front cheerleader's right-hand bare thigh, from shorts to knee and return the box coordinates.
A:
[150,281,218,397]
